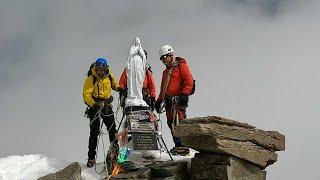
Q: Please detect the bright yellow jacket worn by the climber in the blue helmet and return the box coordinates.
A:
[82,67,119,107]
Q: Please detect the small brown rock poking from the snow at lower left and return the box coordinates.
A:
[38,162,82,180]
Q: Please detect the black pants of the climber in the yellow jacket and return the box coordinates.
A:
[88,106,118,159]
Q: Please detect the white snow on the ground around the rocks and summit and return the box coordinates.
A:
[0,150,195,180]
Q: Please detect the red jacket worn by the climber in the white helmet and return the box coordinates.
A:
[158,57,193,100]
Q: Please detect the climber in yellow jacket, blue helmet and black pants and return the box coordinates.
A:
[82,58,119,167]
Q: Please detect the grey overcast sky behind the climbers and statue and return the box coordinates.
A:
[0,0,320,180]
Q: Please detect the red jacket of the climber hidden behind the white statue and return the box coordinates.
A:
[119,68,156,98]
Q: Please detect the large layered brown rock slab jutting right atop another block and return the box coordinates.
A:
[175,116,285,169]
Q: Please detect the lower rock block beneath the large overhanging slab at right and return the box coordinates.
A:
[191,153,266,180]
